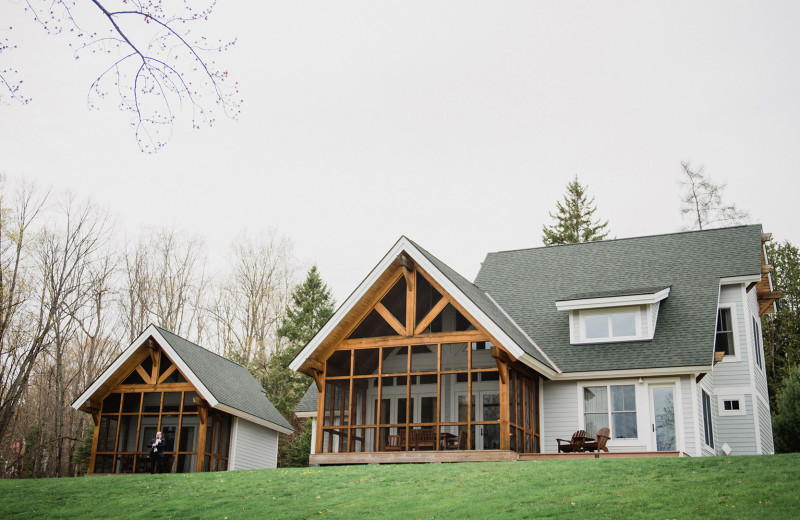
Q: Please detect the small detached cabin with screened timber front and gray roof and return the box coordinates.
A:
[72,325,292,473]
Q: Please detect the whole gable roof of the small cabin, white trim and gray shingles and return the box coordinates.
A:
[72,325,293,433]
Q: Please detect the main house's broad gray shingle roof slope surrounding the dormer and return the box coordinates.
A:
[475,225,761,372]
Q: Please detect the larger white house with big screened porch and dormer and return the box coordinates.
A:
[290,226,780,464]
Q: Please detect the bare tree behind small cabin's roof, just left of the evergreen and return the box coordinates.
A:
[210,231,296,370]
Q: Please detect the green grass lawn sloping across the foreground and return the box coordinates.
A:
[0,454,800,520]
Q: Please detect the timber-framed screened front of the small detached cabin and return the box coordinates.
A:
[82,337,232,474]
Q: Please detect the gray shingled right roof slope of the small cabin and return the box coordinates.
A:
[156,326,292,430]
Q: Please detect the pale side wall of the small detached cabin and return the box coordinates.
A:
[230,417,278,471]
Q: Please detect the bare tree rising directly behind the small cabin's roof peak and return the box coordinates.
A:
[120,229,208,342]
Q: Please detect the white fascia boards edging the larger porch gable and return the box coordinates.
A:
[289,237,558,376]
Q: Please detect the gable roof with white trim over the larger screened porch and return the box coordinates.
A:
[289,236,560,377]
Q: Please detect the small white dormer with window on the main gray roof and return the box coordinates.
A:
[556,286,670,345]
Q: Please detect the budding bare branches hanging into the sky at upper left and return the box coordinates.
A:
[0,0,241,152]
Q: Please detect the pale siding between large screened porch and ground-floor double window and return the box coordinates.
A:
[541,381,578,453]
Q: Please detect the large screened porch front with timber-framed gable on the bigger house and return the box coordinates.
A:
[300,253,541,454]
